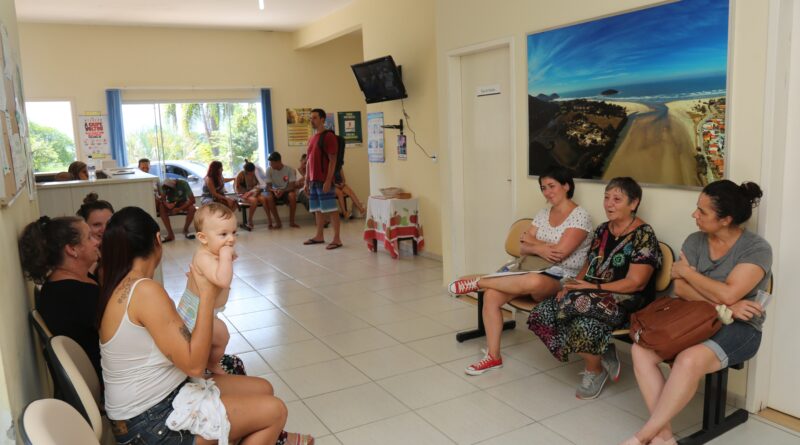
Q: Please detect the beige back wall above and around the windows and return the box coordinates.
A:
[20,23,369,204]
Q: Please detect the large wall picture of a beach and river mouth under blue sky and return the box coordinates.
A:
[527,0,729,187]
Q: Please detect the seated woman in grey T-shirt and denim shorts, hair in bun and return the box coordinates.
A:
[624,180,772,445]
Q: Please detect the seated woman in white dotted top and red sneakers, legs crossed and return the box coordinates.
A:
[450,168,592,375]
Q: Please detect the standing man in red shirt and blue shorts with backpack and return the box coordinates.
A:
[303,108,342,250]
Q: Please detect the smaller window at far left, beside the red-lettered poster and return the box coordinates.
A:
[25,101,76,172]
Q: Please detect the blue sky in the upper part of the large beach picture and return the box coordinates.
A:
[528,0,728,96]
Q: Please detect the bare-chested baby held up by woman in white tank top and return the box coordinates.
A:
[178,202,236,374]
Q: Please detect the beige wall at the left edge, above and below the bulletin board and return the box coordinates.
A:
[0,2,42,434]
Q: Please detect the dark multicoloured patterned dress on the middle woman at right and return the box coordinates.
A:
[528,222,661,362]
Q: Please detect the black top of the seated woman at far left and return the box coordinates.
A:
[36,277,103,382]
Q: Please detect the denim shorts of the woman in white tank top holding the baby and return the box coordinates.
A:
[111,379,194,445]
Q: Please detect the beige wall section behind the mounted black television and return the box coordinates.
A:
[295,0,444,257]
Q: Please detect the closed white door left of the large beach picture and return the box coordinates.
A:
[462,46,513,273]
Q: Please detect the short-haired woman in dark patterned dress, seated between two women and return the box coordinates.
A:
[528,177,661,399]
